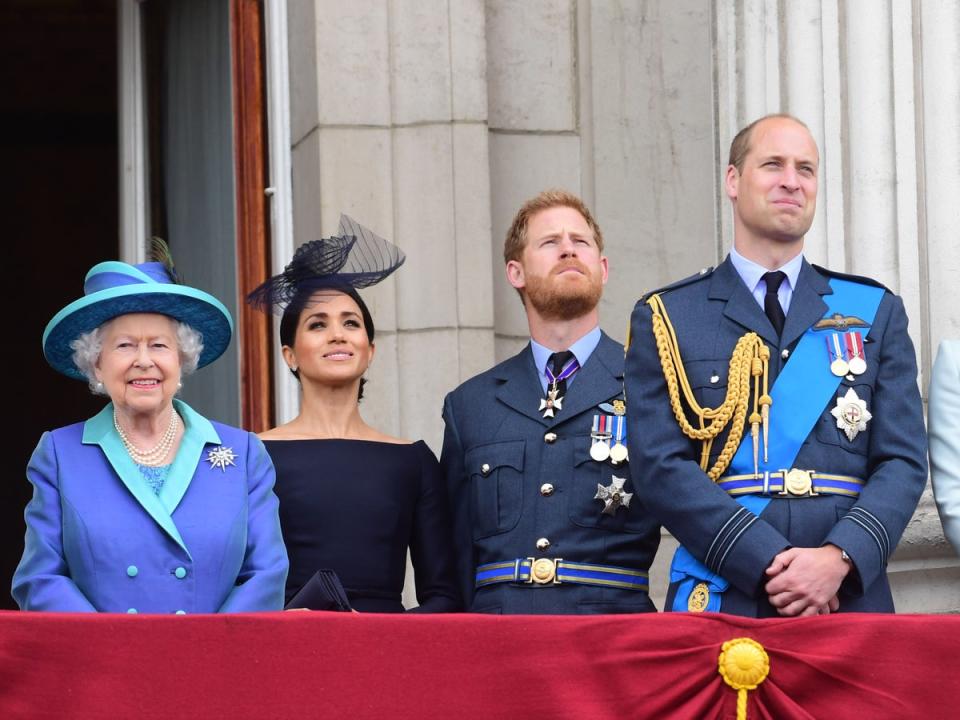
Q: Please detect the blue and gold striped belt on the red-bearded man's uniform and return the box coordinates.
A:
[476,557,648,592]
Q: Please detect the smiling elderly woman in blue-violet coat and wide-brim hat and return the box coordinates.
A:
[13,253,287,614]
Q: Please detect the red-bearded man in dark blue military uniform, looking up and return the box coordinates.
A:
[441,190,660,614]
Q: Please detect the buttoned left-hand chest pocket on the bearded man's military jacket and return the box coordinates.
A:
[464,440,524,540]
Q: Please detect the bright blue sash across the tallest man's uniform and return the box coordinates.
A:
[670,278,885,612]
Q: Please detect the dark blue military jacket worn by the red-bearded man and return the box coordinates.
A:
[440,335,660,614]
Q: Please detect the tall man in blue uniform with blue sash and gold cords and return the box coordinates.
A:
[625,115,927,617]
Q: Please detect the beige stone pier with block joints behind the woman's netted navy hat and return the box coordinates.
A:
[290,0,493,451]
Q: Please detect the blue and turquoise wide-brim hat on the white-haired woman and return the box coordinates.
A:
[43,261,233,380]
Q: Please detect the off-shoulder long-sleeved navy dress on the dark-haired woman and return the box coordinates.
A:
[264,440,461,612]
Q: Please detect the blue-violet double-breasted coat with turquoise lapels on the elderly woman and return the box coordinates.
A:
[13,400,287,614]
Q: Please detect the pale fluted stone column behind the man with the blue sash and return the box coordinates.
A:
[714,0,960,612]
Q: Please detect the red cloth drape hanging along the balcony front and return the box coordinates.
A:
[0,612,960,720]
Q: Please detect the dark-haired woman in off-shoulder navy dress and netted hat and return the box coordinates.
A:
[250,216,460,612]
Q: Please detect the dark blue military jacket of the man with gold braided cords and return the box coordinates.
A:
[625,258,927,616]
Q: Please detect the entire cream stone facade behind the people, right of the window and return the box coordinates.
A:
[282,0,960,612]
